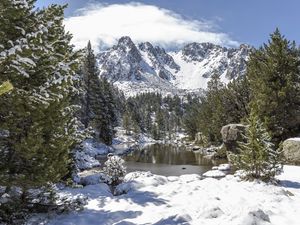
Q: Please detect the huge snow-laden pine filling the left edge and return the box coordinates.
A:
[0,0,78,189]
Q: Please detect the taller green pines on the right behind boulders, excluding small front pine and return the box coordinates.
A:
[184,29,300,147]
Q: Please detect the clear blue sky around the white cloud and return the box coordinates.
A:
[37,0,300,47]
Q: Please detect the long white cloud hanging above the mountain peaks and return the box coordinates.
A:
[65,3,238,49]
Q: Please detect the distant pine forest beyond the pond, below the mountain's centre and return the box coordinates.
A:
[123,93,185,140]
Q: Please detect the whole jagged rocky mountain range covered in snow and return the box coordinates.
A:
[98,37,251,96]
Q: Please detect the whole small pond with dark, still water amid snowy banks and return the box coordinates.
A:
[123,144,226,176]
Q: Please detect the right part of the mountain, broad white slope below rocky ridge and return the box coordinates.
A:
[170,43,250,90]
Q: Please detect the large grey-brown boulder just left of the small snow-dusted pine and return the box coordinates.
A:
[221,124,247,153]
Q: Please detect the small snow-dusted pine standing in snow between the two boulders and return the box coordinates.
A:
[233,112,282,181]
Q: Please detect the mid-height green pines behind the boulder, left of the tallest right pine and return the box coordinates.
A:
[183,74,250,144]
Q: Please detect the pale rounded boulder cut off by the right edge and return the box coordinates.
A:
[283,137,300,165]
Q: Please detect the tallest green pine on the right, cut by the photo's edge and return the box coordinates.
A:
[247,29,300,146]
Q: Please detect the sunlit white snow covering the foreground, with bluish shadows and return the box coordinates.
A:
[29,166,300,225]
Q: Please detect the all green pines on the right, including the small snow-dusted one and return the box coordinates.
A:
[184,29,300,181]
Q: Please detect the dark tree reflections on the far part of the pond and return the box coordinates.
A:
[125,144,224,165]
